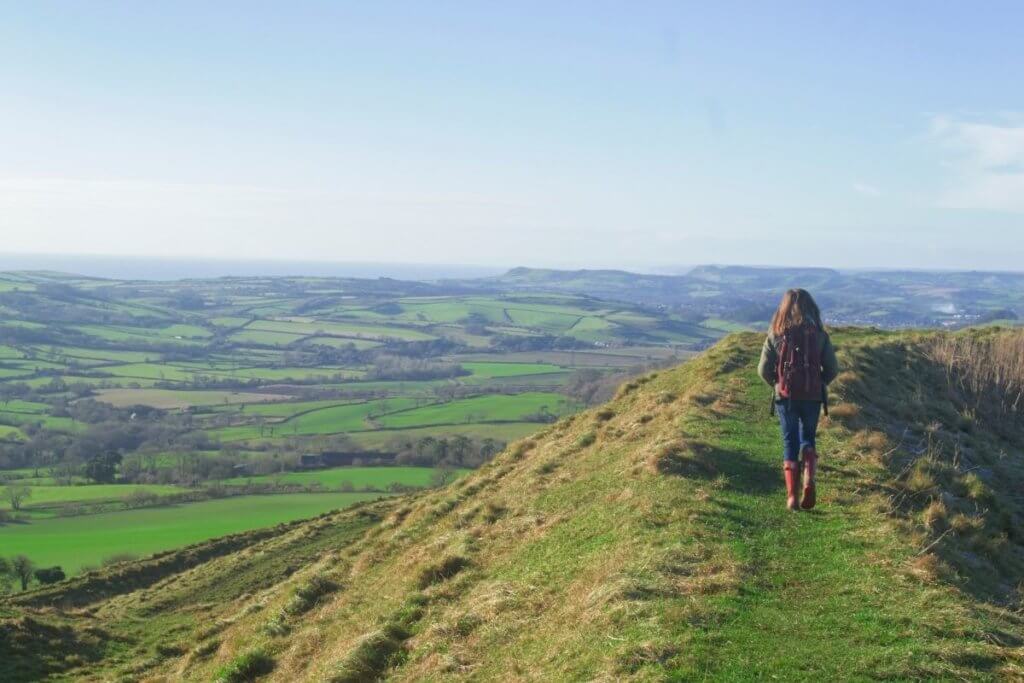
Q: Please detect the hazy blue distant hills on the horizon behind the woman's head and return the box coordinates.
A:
[475,265,1024,328]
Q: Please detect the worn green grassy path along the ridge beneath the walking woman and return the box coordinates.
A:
[678,352,999,681]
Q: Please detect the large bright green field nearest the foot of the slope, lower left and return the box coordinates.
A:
[0,493,380,573]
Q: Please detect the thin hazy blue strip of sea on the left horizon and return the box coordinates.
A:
[0,254,499,281]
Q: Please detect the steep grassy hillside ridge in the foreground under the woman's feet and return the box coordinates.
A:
[0,330,1024,681]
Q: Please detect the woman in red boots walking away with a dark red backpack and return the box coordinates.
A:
[758,289,839,510]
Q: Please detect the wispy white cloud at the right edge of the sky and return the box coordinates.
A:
[930,116,1024,213]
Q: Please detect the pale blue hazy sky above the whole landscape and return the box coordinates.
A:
[0,0,1024,269]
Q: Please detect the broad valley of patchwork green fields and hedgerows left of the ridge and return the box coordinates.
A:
[0,272,723,589]
